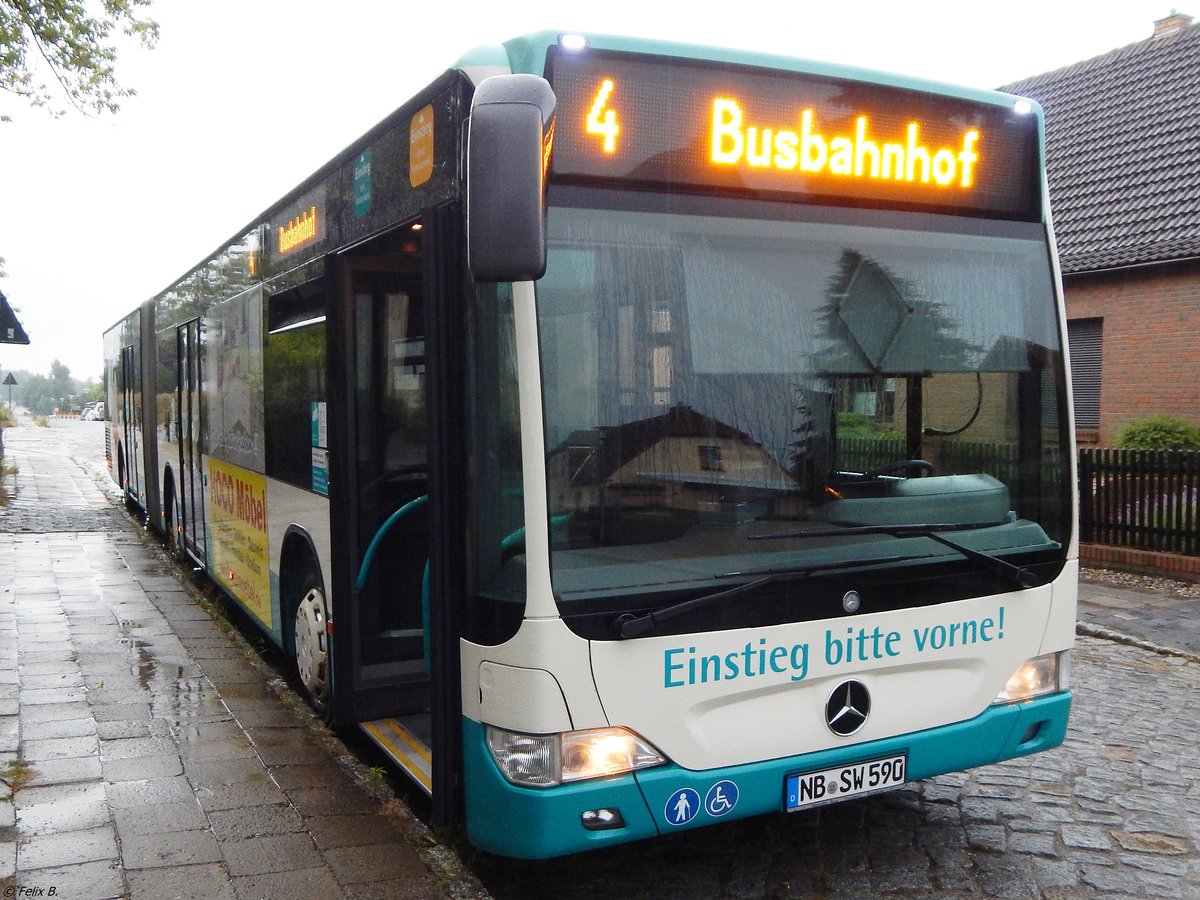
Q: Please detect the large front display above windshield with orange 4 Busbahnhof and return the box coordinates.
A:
[548,50,1039,218]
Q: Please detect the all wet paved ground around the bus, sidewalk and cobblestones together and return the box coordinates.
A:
[0,421,1200,900]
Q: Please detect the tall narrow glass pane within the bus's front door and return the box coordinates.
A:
[350,259,428,670]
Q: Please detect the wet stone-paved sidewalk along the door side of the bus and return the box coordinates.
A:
[0,421,463,900]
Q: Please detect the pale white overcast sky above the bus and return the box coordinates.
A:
[0,0,1180,378]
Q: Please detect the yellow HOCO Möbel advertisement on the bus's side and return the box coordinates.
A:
[209,458,274,629]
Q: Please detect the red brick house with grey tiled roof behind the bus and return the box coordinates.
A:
[1001,12,1200,446]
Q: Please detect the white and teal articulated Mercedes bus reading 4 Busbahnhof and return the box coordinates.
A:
[104,34,1078,858]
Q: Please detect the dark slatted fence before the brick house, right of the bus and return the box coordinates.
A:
[1079,449,1200,556]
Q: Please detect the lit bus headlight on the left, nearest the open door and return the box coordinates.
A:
[487,725,666,787]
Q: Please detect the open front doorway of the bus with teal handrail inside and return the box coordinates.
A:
[331,244,430,734]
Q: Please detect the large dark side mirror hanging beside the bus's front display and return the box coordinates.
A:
[467,74,554,281]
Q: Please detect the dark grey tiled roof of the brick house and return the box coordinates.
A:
[1001,23,1200,274]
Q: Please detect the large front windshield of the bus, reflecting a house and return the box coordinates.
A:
[538,188,1070,636]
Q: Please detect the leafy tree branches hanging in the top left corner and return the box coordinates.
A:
[0,0,158,121]
